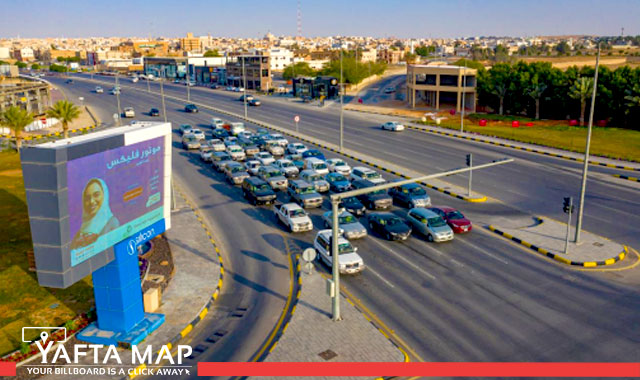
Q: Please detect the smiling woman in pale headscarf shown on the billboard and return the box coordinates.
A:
[71,178,120,249]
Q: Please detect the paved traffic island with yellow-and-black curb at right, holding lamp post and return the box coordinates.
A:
[488,216,628,267]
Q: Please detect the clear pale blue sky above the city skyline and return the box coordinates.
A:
[0,0,640,38]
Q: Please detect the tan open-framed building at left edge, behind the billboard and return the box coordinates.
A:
[0,78,51,115]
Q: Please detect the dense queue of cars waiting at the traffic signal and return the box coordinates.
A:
[179,119,472,273]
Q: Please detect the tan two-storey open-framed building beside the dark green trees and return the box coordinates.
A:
[407,65,477,112]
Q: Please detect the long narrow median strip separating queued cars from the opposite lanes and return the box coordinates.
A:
[70,75,487,203]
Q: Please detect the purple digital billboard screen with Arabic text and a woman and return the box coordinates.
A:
[66,137,165,266]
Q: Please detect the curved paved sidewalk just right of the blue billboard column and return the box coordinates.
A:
[37,192,220,380]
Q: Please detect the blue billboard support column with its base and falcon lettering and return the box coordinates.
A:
[77,219,165,347]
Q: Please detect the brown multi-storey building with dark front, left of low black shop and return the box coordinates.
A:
[226,55,272,92]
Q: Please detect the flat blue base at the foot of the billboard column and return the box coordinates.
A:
[76,313,164,348]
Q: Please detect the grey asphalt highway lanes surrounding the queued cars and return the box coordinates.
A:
[51,78,640,370]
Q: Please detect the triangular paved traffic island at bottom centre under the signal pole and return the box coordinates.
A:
[251,268,405,380]
